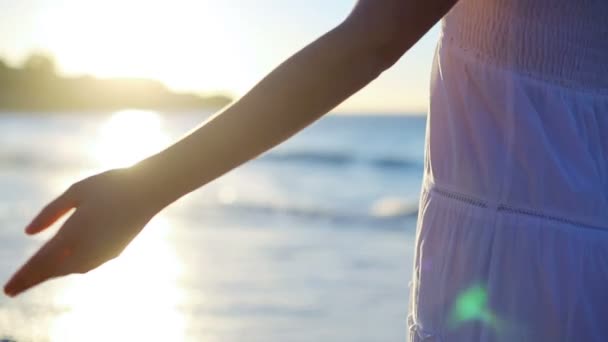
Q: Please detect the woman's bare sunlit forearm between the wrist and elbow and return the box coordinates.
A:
[135,27,392,206]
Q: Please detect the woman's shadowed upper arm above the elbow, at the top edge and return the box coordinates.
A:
[343,0,458,62]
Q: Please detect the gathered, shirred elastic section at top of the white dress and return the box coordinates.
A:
[442,0,608,93]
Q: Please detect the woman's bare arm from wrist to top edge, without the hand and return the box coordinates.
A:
[134,0,453,205]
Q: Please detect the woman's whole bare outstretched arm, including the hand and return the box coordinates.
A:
[4,0,457,297]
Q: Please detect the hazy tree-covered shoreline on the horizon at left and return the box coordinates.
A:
[0,54,231,112]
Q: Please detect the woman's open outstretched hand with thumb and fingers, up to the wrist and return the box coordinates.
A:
[4,169,161,296]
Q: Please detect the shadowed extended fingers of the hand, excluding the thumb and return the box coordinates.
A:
[4,238,72,297]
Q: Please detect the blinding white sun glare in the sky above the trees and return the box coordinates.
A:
[44,0,252,92]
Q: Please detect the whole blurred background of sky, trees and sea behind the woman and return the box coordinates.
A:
[0,0,438,342]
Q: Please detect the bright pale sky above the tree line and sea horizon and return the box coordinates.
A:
[0,0,439,112]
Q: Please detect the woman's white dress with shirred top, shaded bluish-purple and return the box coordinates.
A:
[408,0,608,341]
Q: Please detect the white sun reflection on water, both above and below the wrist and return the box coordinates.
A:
[50,111,186,342]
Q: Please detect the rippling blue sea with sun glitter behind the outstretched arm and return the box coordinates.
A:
[0,110,426,342]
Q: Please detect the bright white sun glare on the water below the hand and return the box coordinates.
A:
[51,216,186,342]
